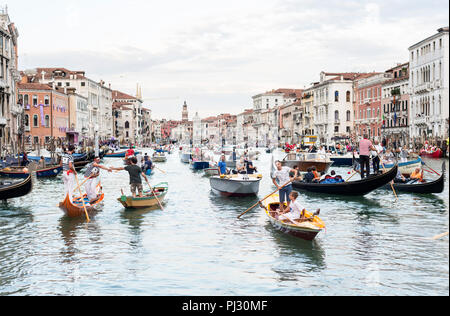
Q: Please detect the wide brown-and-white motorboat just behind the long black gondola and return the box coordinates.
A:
[281,153,333,173]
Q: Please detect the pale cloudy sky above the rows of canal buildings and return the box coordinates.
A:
[5,0,449,119]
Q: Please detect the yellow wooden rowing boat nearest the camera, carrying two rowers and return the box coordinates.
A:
[263,194,326,241]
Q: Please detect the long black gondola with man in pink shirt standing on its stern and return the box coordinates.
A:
[292,165,398,196]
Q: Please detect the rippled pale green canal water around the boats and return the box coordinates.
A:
[0,151,449,296]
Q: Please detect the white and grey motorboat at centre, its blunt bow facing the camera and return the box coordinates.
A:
[210,175,262,197]
